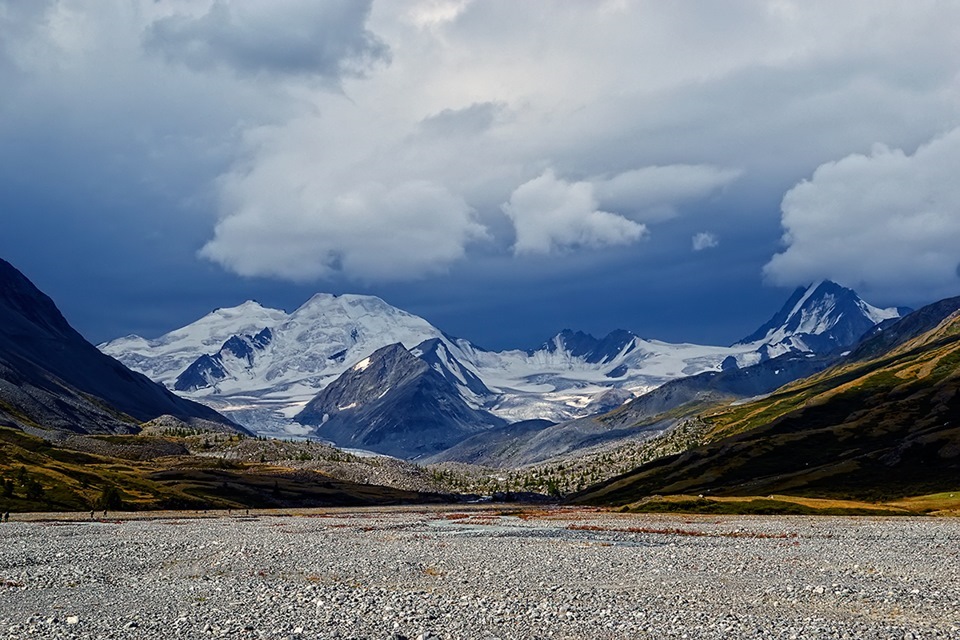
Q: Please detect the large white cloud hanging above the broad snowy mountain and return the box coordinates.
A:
[201,126,486,281]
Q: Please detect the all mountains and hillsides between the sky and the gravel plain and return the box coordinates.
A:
[0,252,960,510]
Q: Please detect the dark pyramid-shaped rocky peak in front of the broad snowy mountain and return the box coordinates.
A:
[296,343,506,458]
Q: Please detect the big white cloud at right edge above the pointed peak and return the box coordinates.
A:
[764,129,960,303]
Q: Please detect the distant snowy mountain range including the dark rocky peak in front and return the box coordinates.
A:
[100,281,901,459]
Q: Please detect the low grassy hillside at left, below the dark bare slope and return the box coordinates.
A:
[0,427,443,511]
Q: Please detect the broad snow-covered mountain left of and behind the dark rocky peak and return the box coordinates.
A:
[100,293,450,435]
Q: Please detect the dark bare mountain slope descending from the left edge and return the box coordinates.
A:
[0,260,236,433]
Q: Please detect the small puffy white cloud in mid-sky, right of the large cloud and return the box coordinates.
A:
[503,171,647,254]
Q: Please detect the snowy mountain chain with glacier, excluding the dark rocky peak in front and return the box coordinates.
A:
[100,282,900,435]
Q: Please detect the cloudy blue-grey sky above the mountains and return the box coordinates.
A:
[0,0,960,349]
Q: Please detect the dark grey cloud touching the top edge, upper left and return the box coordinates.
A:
[144,0,390,84]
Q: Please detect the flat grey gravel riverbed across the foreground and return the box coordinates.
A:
[0,506,960,640]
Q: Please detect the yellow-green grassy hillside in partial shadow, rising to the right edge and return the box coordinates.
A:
[574,314,960,505]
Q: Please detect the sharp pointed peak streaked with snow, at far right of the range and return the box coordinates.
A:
[738,280,910,358]
